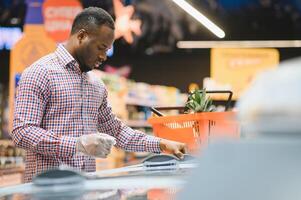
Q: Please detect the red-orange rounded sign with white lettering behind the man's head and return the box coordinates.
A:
[43,0,82,43]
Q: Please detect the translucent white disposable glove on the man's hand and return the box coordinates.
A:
[77,133,116,158]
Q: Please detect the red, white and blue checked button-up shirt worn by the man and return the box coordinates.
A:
[12,45,160,182]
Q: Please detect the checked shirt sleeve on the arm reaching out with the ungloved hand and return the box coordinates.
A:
[98,90,161,153]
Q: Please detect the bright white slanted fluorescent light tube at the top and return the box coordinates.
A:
[172,0,226,38]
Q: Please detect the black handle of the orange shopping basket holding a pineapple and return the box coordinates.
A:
[150,90,233,117]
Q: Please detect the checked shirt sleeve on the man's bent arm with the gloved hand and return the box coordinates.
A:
[11,66,77,158]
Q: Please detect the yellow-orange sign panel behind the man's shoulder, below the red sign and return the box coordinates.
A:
[9,24,56,131]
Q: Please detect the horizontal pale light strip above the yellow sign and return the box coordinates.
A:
[177,40,301,49]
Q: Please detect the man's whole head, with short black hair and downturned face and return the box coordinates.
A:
[68,7,114,72]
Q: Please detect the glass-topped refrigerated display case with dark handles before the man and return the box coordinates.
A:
[0,154,198,200]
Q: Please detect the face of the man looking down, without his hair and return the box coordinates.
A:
[75,25,114,72]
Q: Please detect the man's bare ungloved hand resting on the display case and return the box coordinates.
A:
[160,139,187,159]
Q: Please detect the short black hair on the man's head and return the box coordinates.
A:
[71,7,115,35]
